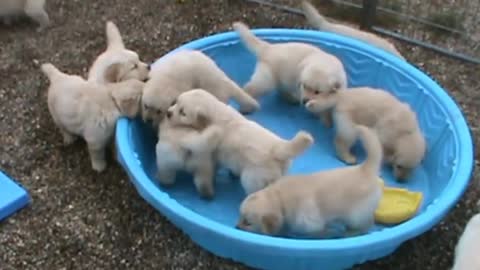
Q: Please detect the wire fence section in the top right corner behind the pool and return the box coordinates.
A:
[247,0,480,64]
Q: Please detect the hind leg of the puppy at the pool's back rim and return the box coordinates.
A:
[244,62,276,98]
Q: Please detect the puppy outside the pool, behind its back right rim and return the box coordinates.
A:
[302,1,405,59]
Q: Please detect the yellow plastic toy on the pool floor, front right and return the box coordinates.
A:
[375,178,423,225]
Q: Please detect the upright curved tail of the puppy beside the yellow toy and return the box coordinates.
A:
[357,125,383,175]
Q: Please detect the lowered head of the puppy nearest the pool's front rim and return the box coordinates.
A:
[236,190,283,235]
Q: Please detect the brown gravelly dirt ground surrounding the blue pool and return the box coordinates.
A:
[0,0,480,270]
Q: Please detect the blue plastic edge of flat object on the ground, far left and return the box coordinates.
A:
[0,171,31,221]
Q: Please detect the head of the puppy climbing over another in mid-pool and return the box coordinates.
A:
[167,89,219,130]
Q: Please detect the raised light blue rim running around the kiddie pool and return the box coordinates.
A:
[116,28,474,255]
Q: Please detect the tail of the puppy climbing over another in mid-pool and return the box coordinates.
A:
[272,131,314,160]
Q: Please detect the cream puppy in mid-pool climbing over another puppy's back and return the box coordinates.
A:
[168,89,313,194]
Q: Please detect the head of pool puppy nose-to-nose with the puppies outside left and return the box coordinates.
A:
[142,85,178,127]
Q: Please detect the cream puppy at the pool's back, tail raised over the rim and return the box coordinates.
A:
[233,22,347,126]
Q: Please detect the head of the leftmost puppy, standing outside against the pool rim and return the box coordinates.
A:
[108,80,145,118]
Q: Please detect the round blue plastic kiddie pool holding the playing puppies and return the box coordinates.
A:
[116,29,473,270]
